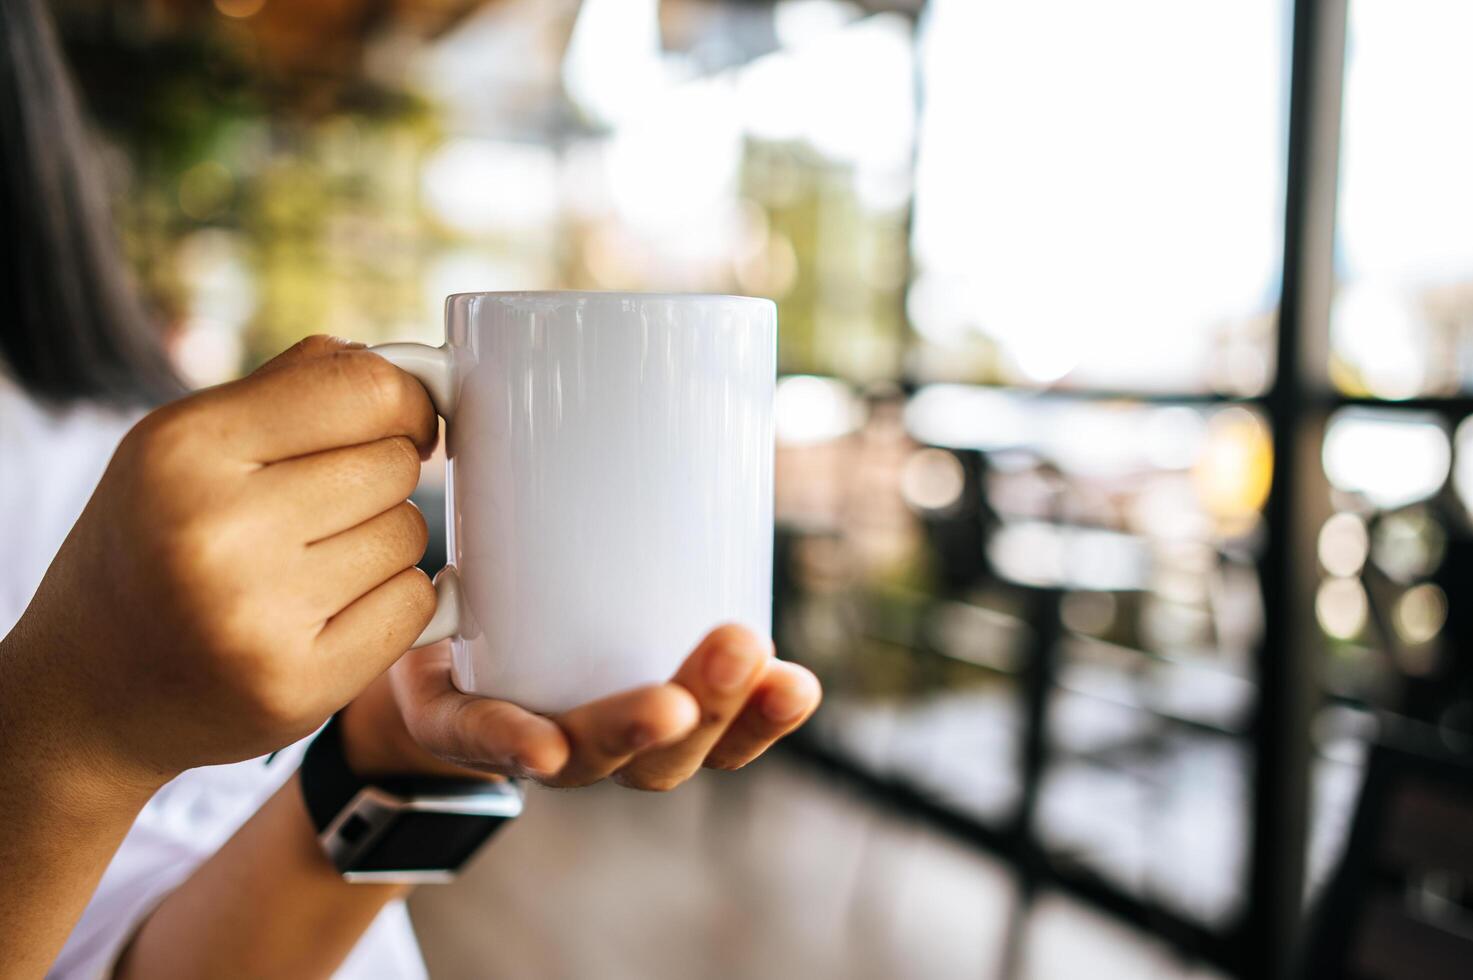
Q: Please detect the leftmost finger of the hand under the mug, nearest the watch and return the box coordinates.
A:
[392,643,569,780]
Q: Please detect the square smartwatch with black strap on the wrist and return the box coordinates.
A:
[300,715,521,884]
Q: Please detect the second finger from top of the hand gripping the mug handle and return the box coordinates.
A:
[250,436,420,541]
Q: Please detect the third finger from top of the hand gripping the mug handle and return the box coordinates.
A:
[302,500,430,616]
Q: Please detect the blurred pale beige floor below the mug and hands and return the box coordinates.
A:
[412,759,1225,980]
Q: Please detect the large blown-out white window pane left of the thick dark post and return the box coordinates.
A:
[915,0,1287,389]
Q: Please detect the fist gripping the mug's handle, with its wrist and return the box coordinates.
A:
[0,337,436,787]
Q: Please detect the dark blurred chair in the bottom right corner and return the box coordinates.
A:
[1304,746,1473,980]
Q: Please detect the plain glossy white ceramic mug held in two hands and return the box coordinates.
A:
[374,292,778,712]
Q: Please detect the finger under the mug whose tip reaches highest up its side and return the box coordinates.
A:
[619,626,772,791]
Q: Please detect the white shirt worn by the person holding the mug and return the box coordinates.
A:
[0,373,427,980]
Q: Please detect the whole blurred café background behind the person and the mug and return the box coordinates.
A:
[53,0,1473,979]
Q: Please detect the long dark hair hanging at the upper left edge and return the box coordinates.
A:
[0,0,183,405]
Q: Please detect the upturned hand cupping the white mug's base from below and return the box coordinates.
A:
[343,626,820,790]
